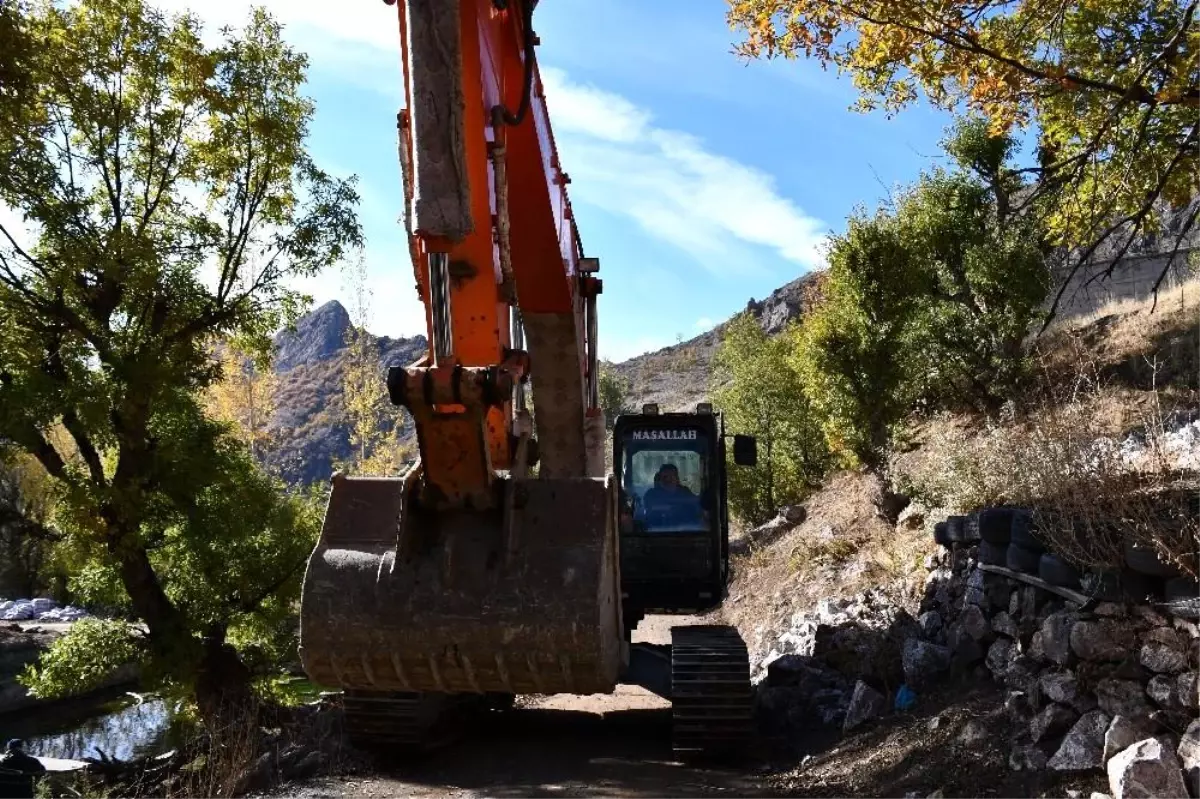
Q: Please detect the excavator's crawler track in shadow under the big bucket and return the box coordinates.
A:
[342,690,486,757]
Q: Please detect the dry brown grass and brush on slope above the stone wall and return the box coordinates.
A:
[893,292,1200,575]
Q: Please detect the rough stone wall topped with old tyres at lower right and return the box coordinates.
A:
[920,511,1200,799]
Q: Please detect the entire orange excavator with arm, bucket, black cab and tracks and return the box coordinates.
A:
[300,0,756,753]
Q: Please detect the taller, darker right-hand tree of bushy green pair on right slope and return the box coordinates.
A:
[893,119,1050,411]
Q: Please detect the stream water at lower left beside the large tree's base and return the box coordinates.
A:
[0,695,182,761]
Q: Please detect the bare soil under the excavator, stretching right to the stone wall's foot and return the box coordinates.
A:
[258,617,1106,799]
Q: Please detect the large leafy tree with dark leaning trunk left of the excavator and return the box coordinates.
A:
[0,0,361,720]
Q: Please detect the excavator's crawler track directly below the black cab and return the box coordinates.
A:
[671,625,754,758]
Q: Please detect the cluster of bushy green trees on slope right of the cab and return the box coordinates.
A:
[796,120,1049,468]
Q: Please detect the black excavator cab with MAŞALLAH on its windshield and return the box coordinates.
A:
[613,403,757,636]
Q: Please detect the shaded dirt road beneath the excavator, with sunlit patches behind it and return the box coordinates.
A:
[272,618,775,799]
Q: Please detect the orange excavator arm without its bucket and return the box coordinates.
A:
[389,0,604,507]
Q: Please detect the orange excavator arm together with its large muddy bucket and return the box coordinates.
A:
[300,0,628,719]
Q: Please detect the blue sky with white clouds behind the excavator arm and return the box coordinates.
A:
[160,0,964,360]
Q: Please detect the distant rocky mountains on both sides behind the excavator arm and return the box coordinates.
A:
[268,275,818,485]
